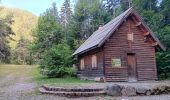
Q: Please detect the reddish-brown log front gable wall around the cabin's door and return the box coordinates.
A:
[103,18,157,81]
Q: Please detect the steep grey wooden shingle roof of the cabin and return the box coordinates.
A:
[73,7,165,55]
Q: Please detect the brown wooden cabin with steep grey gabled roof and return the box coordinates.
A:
[73,8,165,82]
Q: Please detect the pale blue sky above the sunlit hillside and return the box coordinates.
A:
[0,0,67,16]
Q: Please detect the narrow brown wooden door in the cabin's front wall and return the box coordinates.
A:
[127,53,137,82]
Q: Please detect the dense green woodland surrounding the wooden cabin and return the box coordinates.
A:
[0,0,170,78]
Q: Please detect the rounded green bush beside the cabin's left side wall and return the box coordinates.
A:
[40,43,74,77]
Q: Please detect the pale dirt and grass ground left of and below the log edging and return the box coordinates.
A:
[0,65,170,100]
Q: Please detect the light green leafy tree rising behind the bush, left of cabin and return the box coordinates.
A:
[32,10,62,57]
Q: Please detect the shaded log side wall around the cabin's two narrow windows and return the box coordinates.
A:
[77,48,104,79]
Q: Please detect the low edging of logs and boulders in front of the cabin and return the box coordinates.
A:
[39,84,170,97]
